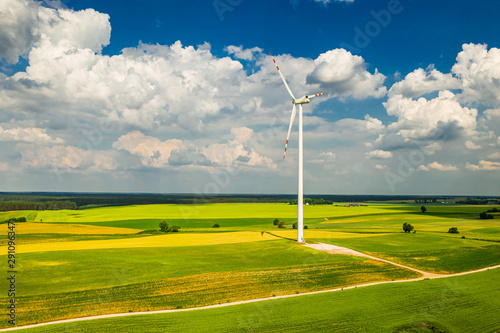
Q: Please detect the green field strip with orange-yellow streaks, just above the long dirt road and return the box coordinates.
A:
[8,260,417,325]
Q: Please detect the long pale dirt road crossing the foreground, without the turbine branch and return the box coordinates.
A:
[0,257,500,332]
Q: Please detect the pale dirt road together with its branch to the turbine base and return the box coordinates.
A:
[0,243,500,332]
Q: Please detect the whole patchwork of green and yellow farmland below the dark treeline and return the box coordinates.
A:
[0,193,500,332]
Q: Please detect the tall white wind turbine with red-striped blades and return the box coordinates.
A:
[271,54,325,243]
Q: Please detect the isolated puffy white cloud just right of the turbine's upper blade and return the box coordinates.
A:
[307,49,387,99]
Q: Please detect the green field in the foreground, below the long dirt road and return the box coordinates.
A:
[14,269,500,333]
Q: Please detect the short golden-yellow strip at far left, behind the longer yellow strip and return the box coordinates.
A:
[16,222,142,235]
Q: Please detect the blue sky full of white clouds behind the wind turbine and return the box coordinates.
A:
[0,0,500,195]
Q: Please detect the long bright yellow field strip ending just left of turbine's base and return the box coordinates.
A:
[17,231,276,253]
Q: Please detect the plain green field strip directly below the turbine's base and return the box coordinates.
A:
[14,240,406,296]
